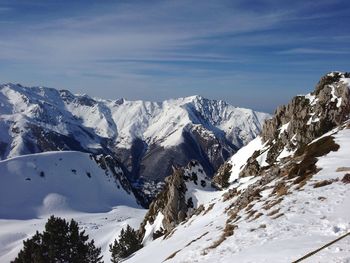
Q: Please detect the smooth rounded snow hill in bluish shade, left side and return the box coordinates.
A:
[0,152,137,219]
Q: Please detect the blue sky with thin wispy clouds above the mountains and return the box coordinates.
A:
[0,0,350,112]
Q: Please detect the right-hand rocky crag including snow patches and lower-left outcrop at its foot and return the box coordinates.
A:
[240,72,350,177]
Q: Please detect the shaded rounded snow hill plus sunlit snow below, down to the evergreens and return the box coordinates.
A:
[0,152,146,262]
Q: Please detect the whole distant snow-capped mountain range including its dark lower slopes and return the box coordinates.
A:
[0,84,269,202]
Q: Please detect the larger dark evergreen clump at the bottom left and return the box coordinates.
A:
[12,216,102,263]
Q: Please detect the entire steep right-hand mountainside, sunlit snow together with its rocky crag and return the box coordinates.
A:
[126,72,350,262]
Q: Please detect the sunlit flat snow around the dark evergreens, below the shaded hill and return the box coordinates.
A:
[0,206,146,262]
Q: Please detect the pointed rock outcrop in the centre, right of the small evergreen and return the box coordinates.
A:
[139,161,213,241]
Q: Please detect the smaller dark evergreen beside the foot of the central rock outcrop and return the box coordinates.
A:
[109,225,142,263]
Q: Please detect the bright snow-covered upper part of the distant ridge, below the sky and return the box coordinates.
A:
[0,84,269,152]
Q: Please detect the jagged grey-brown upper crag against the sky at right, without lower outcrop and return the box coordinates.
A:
[261,72,350,148]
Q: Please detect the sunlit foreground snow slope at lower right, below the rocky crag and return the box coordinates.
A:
[126,129,350,263]
